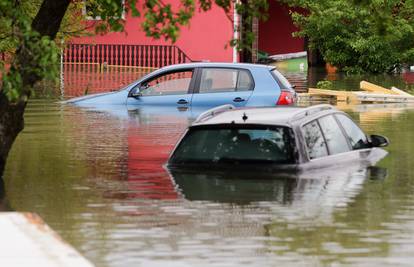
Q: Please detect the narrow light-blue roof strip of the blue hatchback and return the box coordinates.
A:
[160,62,275,71]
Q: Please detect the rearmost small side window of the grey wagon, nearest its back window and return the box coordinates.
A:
[302,120,328,159]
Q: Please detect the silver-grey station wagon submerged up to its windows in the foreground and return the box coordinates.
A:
[168,105,388,170]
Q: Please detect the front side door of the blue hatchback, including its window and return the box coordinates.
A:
[127,69,194,110]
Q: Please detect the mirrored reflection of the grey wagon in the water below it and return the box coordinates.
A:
[170,164,387,209]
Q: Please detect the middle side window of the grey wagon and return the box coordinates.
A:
[319,115,351,155]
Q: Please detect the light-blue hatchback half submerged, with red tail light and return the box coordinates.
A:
[66,62,296,109]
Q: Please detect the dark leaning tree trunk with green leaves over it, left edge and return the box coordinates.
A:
[0,0,70,178]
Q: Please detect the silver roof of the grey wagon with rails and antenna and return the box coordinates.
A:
[193,104,337,126]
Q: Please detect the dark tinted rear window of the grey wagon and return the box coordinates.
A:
[170,125,294,164]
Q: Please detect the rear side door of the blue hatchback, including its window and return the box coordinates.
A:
[192,67,254,107]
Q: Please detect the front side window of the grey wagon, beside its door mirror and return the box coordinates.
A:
[335,114,370,150]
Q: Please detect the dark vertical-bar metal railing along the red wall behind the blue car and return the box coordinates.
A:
[63,44,191,68]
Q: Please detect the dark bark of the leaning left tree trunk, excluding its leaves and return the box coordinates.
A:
[0,0,71,179]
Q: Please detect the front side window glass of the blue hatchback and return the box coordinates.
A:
[140,70,193,96]
